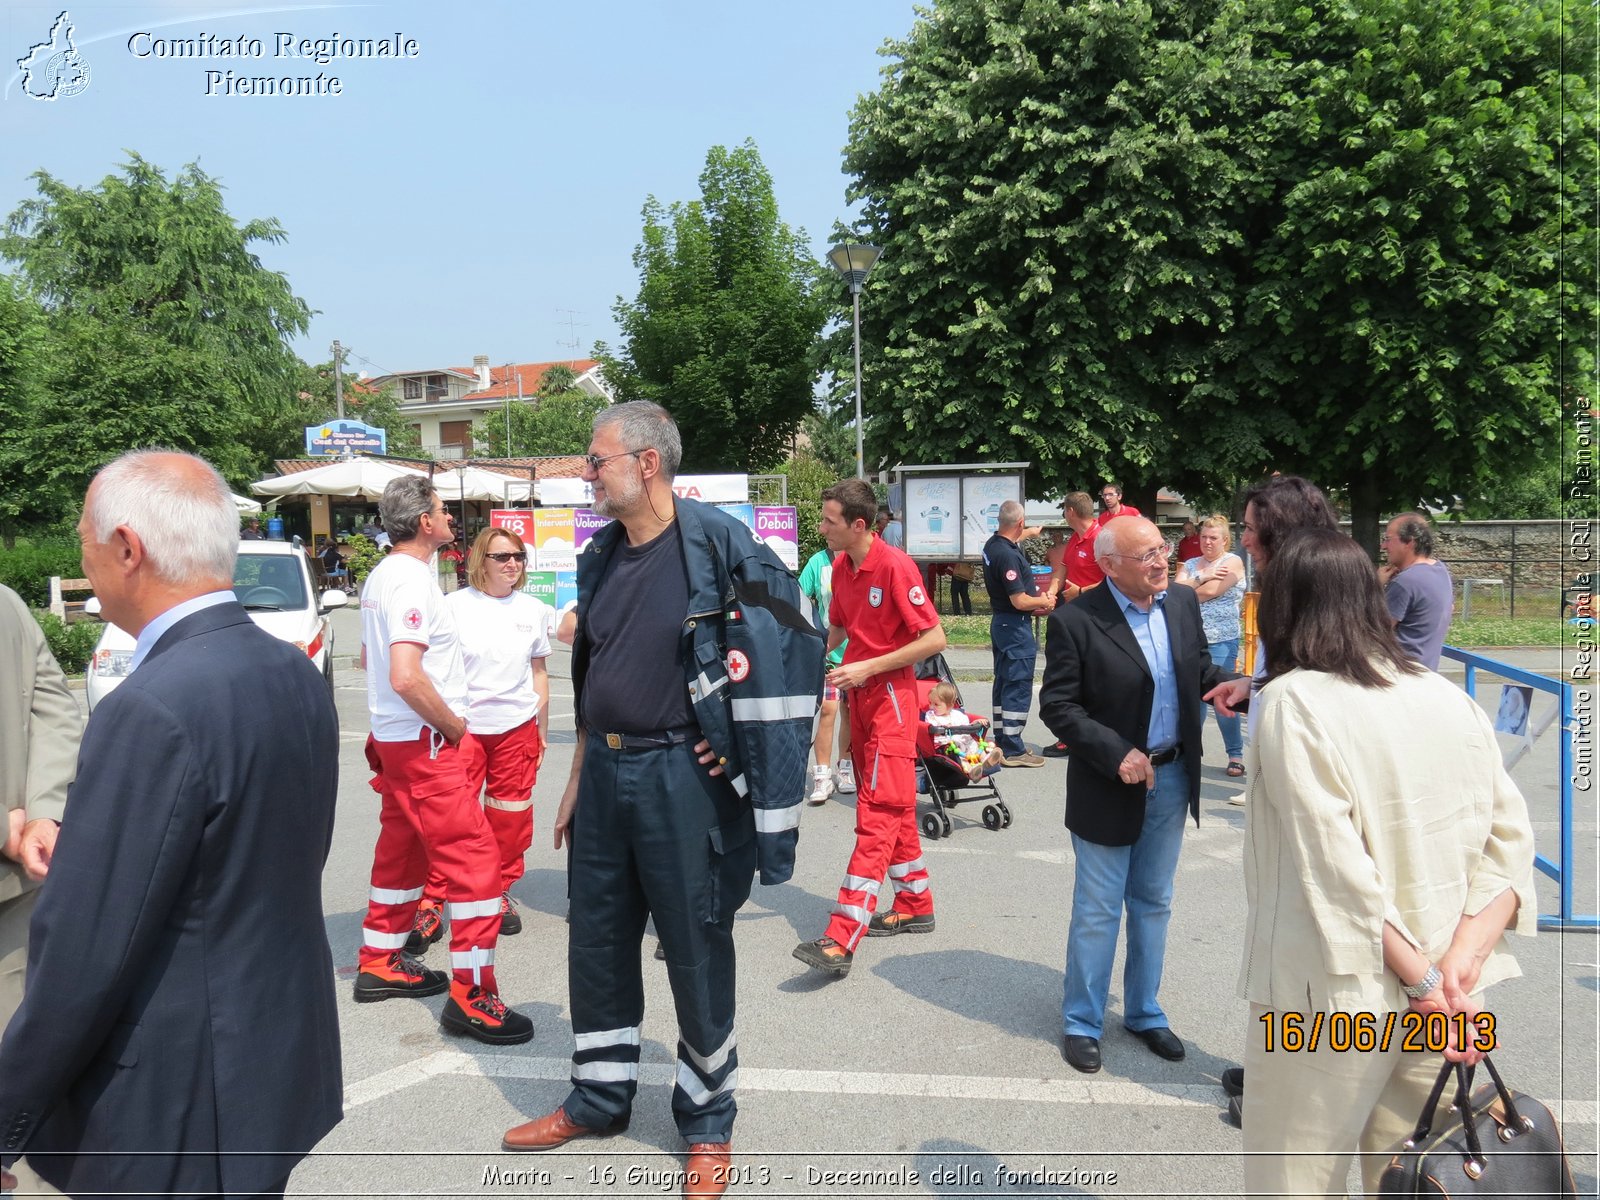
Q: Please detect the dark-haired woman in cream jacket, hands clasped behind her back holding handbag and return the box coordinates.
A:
[1240,528,1538,1198]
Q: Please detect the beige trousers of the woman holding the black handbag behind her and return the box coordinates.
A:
[1243,1005,1453,1200]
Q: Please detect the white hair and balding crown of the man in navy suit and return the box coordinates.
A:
[88,450,238,584]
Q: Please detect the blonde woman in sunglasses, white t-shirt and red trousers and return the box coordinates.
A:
[408,528,555,952]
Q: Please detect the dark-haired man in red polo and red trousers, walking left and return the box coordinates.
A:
[795,478,944,976]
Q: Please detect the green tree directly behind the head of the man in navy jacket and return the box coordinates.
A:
[595,141,826,470]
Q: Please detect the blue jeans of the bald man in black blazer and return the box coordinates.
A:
[1061,760,1189,1038]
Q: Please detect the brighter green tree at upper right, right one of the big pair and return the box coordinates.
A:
[1237,0,1600,554]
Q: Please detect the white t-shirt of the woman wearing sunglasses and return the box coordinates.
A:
[445,587,552,733]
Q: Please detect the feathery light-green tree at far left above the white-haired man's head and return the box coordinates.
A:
[0,155,310,517]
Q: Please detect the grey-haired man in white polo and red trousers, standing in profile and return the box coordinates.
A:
[355,475,533,1045]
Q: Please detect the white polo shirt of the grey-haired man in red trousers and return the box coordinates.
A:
[362,554,467,742]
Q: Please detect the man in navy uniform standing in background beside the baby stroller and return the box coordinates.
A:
[984,501,1056,766]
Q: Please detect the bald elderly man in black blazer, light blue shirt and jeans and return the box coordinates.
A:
[1038,517,1234,1072]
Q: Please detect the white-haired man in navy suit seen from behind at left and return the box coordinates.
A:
[0,451,342,1197]
